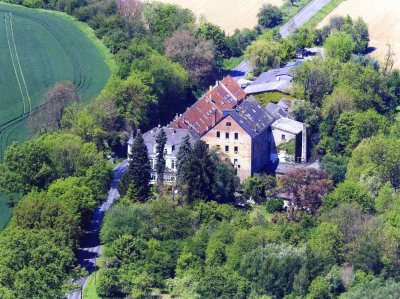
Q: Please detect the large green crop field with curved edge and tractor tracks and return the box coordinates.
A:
[0,3,113,229]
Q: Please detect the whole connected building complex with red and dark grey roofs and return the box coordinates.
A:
[128,76,307,184]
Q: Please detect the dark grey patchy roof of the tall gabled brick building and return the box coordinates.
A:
[221,97,274,138]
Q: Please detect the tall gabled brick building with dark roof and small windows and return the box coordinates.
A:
[201,97,274,181]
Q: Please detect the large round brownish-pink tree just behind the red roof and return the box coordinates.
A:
[165,29,215,84]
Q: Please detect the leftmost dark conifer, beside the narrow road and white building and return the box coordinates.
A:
[128,131,151,201]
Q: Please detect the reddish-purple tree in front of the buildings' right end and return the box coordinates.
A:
[282,168,331,220]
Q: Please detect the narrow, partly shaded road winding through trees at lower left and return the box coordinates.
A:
[67,160,128,299]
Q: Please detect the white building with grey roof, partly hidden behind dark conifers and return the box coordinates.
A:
[128,126,194,185]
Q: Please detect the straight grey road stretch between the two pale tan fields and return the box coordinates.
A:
[279,0,330,38]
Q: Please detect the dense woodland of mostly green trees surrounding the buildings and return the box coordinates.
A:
[0,0,400,299]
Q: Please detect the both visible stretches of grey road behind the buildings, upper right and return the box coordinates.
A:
[229,0,330,81]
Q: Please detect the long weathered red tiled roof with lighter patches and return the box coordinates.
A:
[170,76,246,135]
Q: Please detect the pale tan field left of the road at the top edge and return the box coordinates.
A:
[148,0,284,34]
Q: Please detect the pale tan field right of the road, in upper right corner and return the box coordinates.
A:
[318,0,400,68]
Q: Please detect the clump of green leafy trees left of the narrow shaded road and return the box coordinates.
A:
[0,131,111,299]
